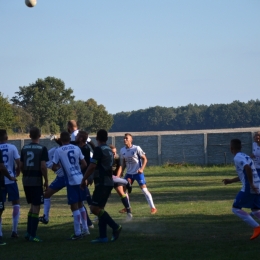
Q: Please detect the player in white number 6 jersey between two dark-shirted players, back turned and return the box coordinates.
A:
[52,132,89,240]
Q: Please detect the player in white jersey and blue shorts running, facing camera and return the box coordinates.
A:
[117,133,157,214]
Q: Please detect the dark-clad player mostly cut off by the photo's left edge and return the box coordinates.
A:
[0,147,16,246]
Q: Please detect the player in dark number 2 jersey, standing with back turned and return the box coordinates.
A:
[21,127,49,242]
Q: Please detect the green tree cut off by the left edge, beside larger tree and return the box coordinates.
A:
[0,92,14,130]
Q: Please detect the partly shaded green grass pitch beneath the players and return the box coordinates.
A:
[0,166,260,260]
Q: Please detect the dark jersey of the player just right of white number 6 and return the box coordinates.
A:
[90,144,114,186]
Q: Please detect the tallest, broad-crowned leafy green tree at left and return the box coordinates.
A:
[11,77,74,131]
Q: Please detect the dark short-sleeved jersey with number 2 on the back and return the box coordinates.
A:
[21,143,49,186]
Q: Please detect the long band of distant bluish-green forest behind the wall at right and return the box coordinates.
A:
[110,99,260,132]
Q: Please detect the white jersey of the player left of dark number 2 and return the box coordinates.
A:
[0,143,20,184]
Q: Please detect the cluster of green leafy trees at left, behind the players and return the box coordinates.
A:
[0,77,113,133]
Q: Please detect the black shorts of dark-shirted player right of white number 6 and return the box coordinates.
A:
[91,185,113,208]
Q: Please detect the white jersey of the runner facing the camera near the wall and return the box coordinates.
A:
[120,145,145,174]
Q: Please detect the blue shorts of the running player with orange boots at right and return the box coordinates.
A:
[233,191,260,209]
